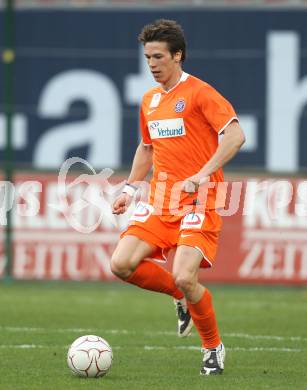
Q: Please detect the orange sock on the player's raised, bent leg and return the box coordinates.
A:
[126,260,183,299]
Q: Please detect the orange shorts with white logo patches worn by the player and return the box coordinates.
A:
[121,202,222,268]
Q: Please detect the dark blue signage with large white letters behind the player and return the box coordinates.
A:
[0,9,307,172]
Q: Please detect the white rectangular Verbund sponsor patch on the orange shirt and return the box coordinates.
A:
[148,118,186,139]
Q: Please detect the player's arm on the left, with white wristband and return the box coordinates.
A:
[112,142,152,214]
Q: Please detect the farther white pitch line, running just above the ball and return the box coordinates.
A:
[0,326,307,341]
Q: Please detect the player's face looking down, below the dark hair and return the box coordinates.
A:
[144,41,182,88]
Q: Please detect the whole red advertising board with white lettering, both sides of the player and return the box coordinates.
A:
[0,174,307,284]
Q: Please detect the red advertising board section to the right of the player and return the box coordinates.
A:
[202,178,307,284]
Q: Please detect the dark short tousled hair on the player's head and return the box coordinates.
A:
[138,19,186,62]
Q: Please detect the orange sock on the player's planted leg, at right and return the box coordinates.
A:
[188,289,221,348]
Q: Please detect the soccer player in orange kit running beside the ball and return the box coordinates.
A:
[111,19,245,375]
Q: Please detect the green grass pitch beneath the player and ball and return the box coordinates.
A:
[0,282,307,390]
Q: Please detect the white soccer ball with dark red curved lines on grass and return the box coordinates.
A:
[67,335,113,378]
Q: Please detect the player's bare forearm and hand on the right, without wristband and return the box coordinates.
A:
[183,120,245,193]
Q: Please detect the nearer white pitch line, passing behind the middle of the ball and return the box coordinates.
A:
[0,344,304,352]
